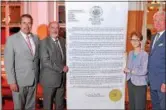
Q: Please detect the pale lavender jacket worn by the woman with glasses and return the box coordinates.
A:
[127,50,148,86]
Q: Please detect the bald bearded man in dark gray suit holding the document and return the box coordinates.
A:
[40,22,68,110]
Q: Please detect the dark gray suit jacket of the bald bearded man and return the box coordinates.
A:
[40,37,66,87]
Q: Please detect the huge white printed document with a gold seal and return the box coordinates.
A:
[65,2,128,109]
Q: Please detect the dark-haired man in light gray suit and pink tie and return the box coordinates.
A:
[4,14,39,110]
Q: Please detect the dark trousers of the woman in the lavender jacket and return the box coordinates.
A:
[127,80,147,110]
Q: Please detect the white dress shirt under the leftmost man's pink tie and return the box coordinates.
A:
[20,31,36,55]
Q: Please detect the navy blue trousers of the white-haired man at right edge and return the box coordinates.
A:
[150,90,166,110]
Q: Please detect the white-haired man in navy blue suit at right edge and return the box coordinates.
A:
[148,11,166,110]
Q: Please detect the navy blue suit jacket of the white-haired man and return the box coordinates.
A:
[148,31,166,90]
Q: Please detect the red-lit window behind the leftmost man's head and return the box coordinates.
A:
[1,1,22,44]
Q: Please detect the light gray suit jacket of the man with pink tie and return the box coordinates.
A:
[4,32,39,87]
